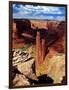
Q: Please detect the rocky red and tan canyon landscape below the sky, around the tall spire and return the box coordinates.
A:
[12,20,66,86]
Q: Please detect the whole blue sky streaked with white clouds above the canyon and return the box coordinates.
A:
[12,4,65,21]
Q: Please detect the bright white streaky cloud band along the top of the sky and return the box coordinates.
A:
[13,4,62,14]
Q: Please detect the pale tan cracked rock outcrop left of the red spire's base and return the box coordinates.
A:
[12,49,38,86]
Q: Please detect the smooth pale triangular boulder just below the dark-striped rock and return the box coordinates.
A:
[17,59,37,80]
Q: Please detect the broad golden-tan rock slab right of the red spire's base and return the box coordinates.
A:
[37,54,65,84]
